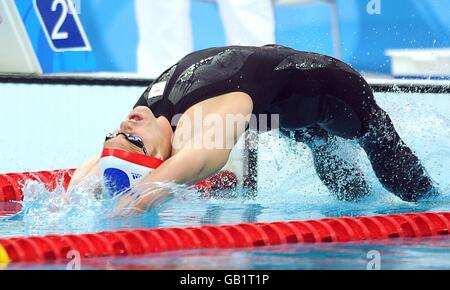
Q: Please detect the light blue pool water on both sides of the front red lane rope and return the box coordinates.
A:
[0,94,450,269]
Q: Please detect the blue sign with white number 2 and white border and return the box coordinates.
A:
[33,0,91,52]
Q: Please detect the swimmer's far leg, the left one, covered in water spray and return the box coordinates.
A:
[286,127,369,201]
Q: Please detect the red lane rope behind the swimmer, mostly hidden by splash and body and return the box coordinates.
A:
[0,169,237,202]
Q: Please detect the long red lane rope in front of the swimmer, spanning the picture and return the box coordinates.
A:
[0,213,450,263]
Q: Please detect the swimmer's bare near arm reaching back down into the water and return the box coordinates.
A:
[122,93,253,211]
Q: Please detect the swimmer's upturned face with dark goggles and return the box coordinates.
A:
[104,106,161,154]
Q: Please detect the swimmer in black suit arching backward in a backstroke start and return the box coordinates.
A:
[70,45,435,210]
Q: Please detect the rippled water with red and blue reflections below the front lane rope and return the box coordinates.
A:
[8,237,450,270]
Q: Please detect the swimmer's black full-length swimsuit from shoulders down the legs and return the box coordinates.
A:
[136,45,432,201]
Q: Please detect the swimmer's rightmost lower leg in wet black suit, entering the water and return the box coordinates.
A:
[359,106,437,202]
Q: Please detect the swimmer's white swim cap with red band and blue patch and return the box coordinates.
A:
[100,149,163,196]
